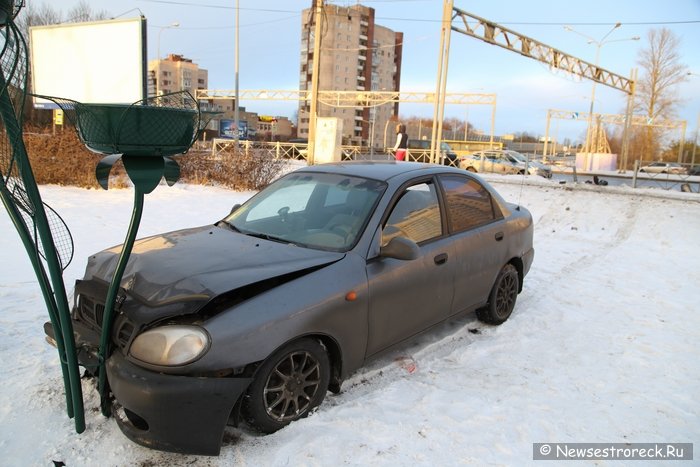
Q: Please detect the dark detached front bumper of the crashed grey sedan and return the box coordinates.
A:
[107,352,252,456]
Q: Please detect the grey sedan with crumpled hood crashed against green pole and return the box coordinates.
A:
[46,162,534,455]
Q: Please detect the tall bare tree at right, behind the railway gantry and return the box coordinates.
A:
[633,28,687,160]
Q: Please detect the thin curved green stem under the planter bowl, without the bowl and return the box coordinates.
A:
[98,185,144,417]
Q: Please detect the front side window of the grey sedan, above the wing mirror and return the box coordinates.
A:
[382,182,442,245]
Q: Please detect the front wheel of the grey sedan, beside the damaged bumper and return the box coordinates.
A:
[243,338,330,433]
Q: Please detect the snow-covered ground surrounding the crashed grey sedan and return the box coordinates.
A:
[0,176,700,466]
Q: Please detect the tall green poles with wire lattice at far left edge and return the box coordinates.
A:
[0,0,85,433]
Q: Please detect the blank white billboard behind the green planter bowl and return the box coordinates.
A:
[29,17,147,108]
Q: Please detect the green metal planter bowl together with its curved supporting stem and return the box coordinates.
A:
[45,91,204,415]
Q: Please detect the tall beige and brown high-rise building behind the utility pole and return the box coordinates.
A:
[298,0,403,148]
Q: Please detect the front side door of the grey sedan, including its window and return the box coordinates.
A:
[367,180,455,355]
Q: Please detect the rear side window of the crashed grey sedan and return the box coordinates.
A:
[440,175,502,232]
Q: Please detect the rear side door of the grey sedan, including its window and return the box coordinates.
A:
[439,174,509,313]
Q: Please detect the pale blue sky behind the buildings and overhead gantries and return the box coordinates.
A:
[45,0,700,144]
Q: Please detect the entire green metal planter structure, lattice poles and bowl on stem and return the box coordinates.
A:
[0,0,205,433]
